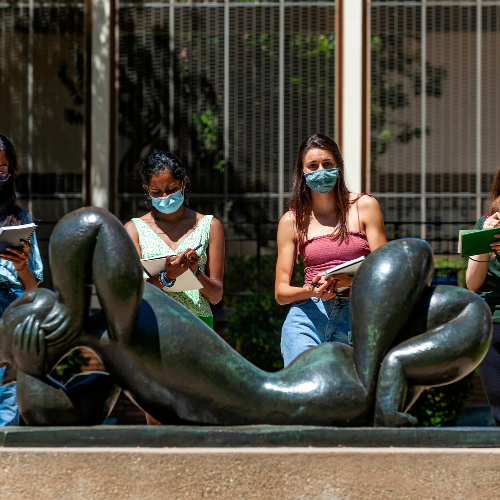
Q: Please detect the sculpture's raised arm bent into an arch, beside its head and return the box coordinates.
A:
[49,207,143,344]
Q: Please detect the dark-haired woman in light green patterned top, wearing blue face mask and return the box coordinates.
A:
[125,151,224,334]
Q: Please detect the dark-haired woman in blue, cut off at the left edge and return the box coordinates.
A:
[0,134,43,426]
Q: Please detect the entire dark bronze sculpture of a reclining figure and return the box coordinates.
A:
[0,208,492,426]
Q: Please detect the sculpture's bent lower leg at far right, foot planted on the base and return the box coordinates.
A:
[375,296,491,427]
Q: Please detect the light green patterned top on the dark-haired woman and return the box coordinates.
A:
[132,215,213,318]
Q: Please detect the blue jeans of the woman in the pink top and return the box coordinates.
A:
[281,297,352,366]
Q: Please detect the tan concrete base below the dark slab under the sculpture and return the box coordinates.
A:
[0,448,500,500]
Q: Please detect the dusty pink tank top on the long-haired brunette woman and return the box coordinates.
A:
[297,195,370,286]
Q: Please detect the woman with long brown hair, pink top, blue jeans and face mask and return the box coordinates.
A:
[275,134,387,366]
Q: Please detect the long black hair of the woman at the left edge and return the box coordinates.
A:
[0,133,23,226]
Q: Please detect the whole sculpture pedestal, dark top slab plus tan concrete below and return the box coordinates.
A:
[0,426,500,500]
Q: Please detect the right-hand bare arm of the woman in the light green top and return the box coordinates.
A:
[185,217,225,304]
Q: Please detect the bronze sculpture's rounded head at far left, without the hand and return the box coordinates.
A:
[0,288,69,385]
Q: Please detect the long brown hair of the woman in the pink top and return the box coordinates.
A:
[288,134,350,243]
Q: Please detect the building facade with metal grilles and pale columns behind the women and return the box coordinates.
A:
[0,0,500,280]
